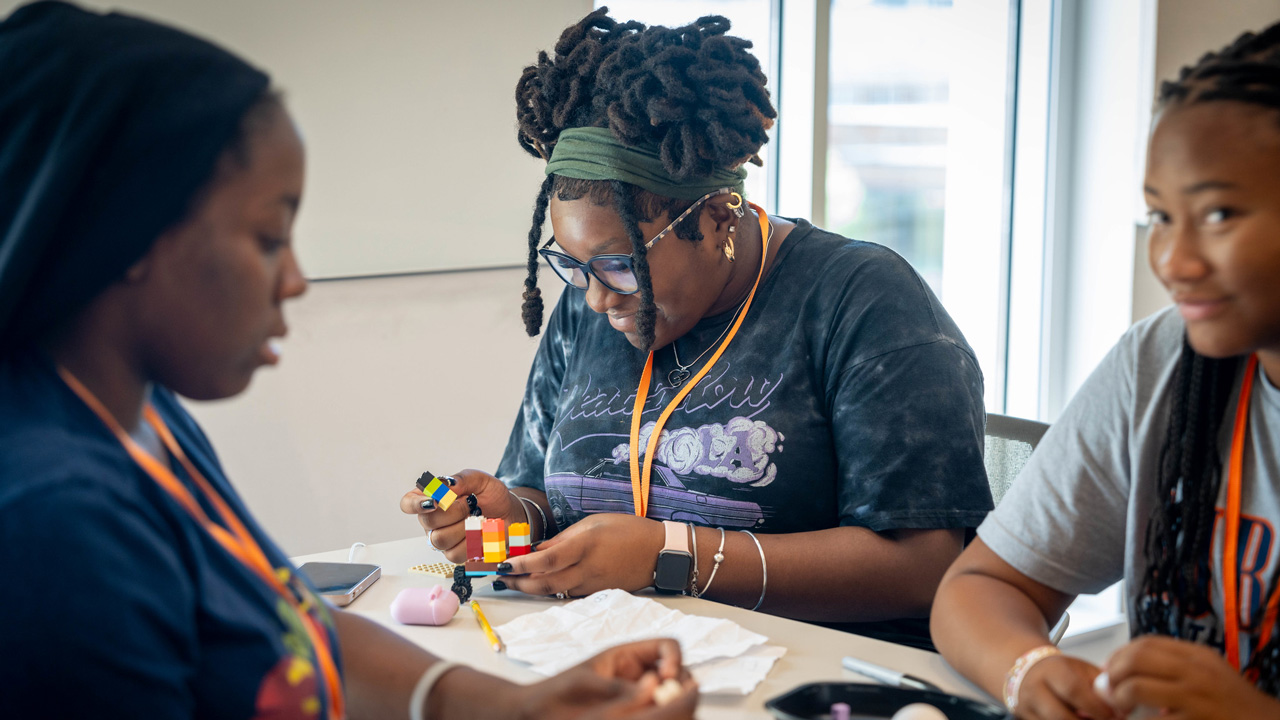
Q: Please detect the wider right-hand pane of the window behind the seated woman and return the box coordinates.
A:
[815,0,1011,409]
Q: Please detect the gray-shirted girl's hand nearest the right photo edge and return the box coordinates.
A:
[1106,635,1280,720]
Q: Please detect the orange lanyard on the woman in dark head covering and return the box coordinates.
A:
[58,368,346,720]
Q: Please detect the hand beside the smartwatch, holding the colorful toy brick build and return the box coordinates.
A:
[502,512,666,597]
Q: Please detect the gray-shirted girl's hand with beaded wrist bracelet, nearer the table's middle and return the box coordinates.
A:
[1018,655,1124,720]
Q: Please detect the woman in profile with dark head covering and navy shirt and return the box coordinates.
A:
[0,3,696,720]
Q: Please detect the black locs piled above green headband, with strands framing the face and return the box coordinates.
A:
[516,8,777,346]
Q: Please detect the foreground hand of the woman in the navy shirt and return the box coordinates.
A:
[517,639,698,720]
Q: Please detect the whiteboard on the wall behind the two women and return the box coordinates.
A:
[0,0,591,278]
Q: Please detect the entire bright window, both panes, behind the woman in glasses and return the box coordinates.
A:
[598,0,1048,413]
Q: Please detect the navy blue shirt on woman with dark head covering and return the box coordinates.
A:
[0,355,337,720]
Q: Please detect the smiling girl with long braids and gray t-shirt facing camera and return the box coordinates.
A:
[933,24,1280,719]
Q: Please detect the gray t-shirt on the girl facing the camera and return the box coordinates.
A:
[978,309,1280,659]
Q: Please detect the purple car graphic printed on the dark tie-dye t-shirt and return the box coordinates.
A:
[545,459,764,528]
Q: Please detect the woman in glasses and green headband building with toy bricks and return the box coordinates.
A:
[402,9,991,642]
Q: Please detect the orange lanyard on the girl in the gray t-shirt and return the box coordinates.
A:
[1222,355,1280,670]
